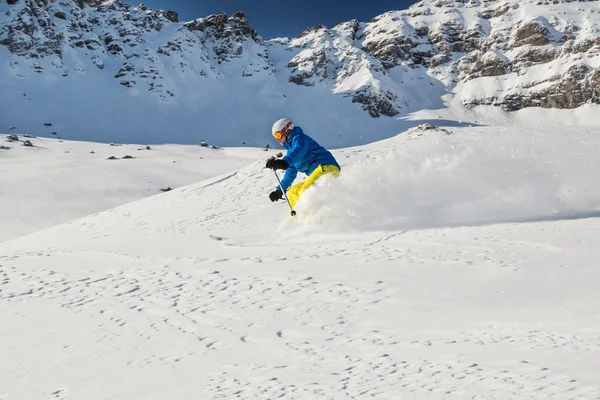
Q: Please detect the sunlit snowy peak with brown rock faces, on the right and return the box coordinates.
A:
[278,0,600,117]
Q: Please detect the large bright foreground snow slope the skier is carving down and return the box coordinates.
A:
[0,127,600,400]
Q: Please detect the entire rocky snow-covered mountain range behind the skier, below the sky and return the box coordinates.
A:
[0,0,600,146]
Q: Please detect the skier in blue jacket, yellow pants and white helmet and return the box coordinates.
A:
[266,118,340,208]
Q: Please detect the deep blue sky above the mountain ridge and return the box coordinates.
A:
[137,0,416,39]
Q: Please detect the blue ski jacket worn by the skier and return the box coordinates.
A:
[281,126,341,190]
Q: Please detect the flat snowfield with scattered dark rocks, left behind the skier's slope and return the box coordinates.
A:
[0,135,267,242]
